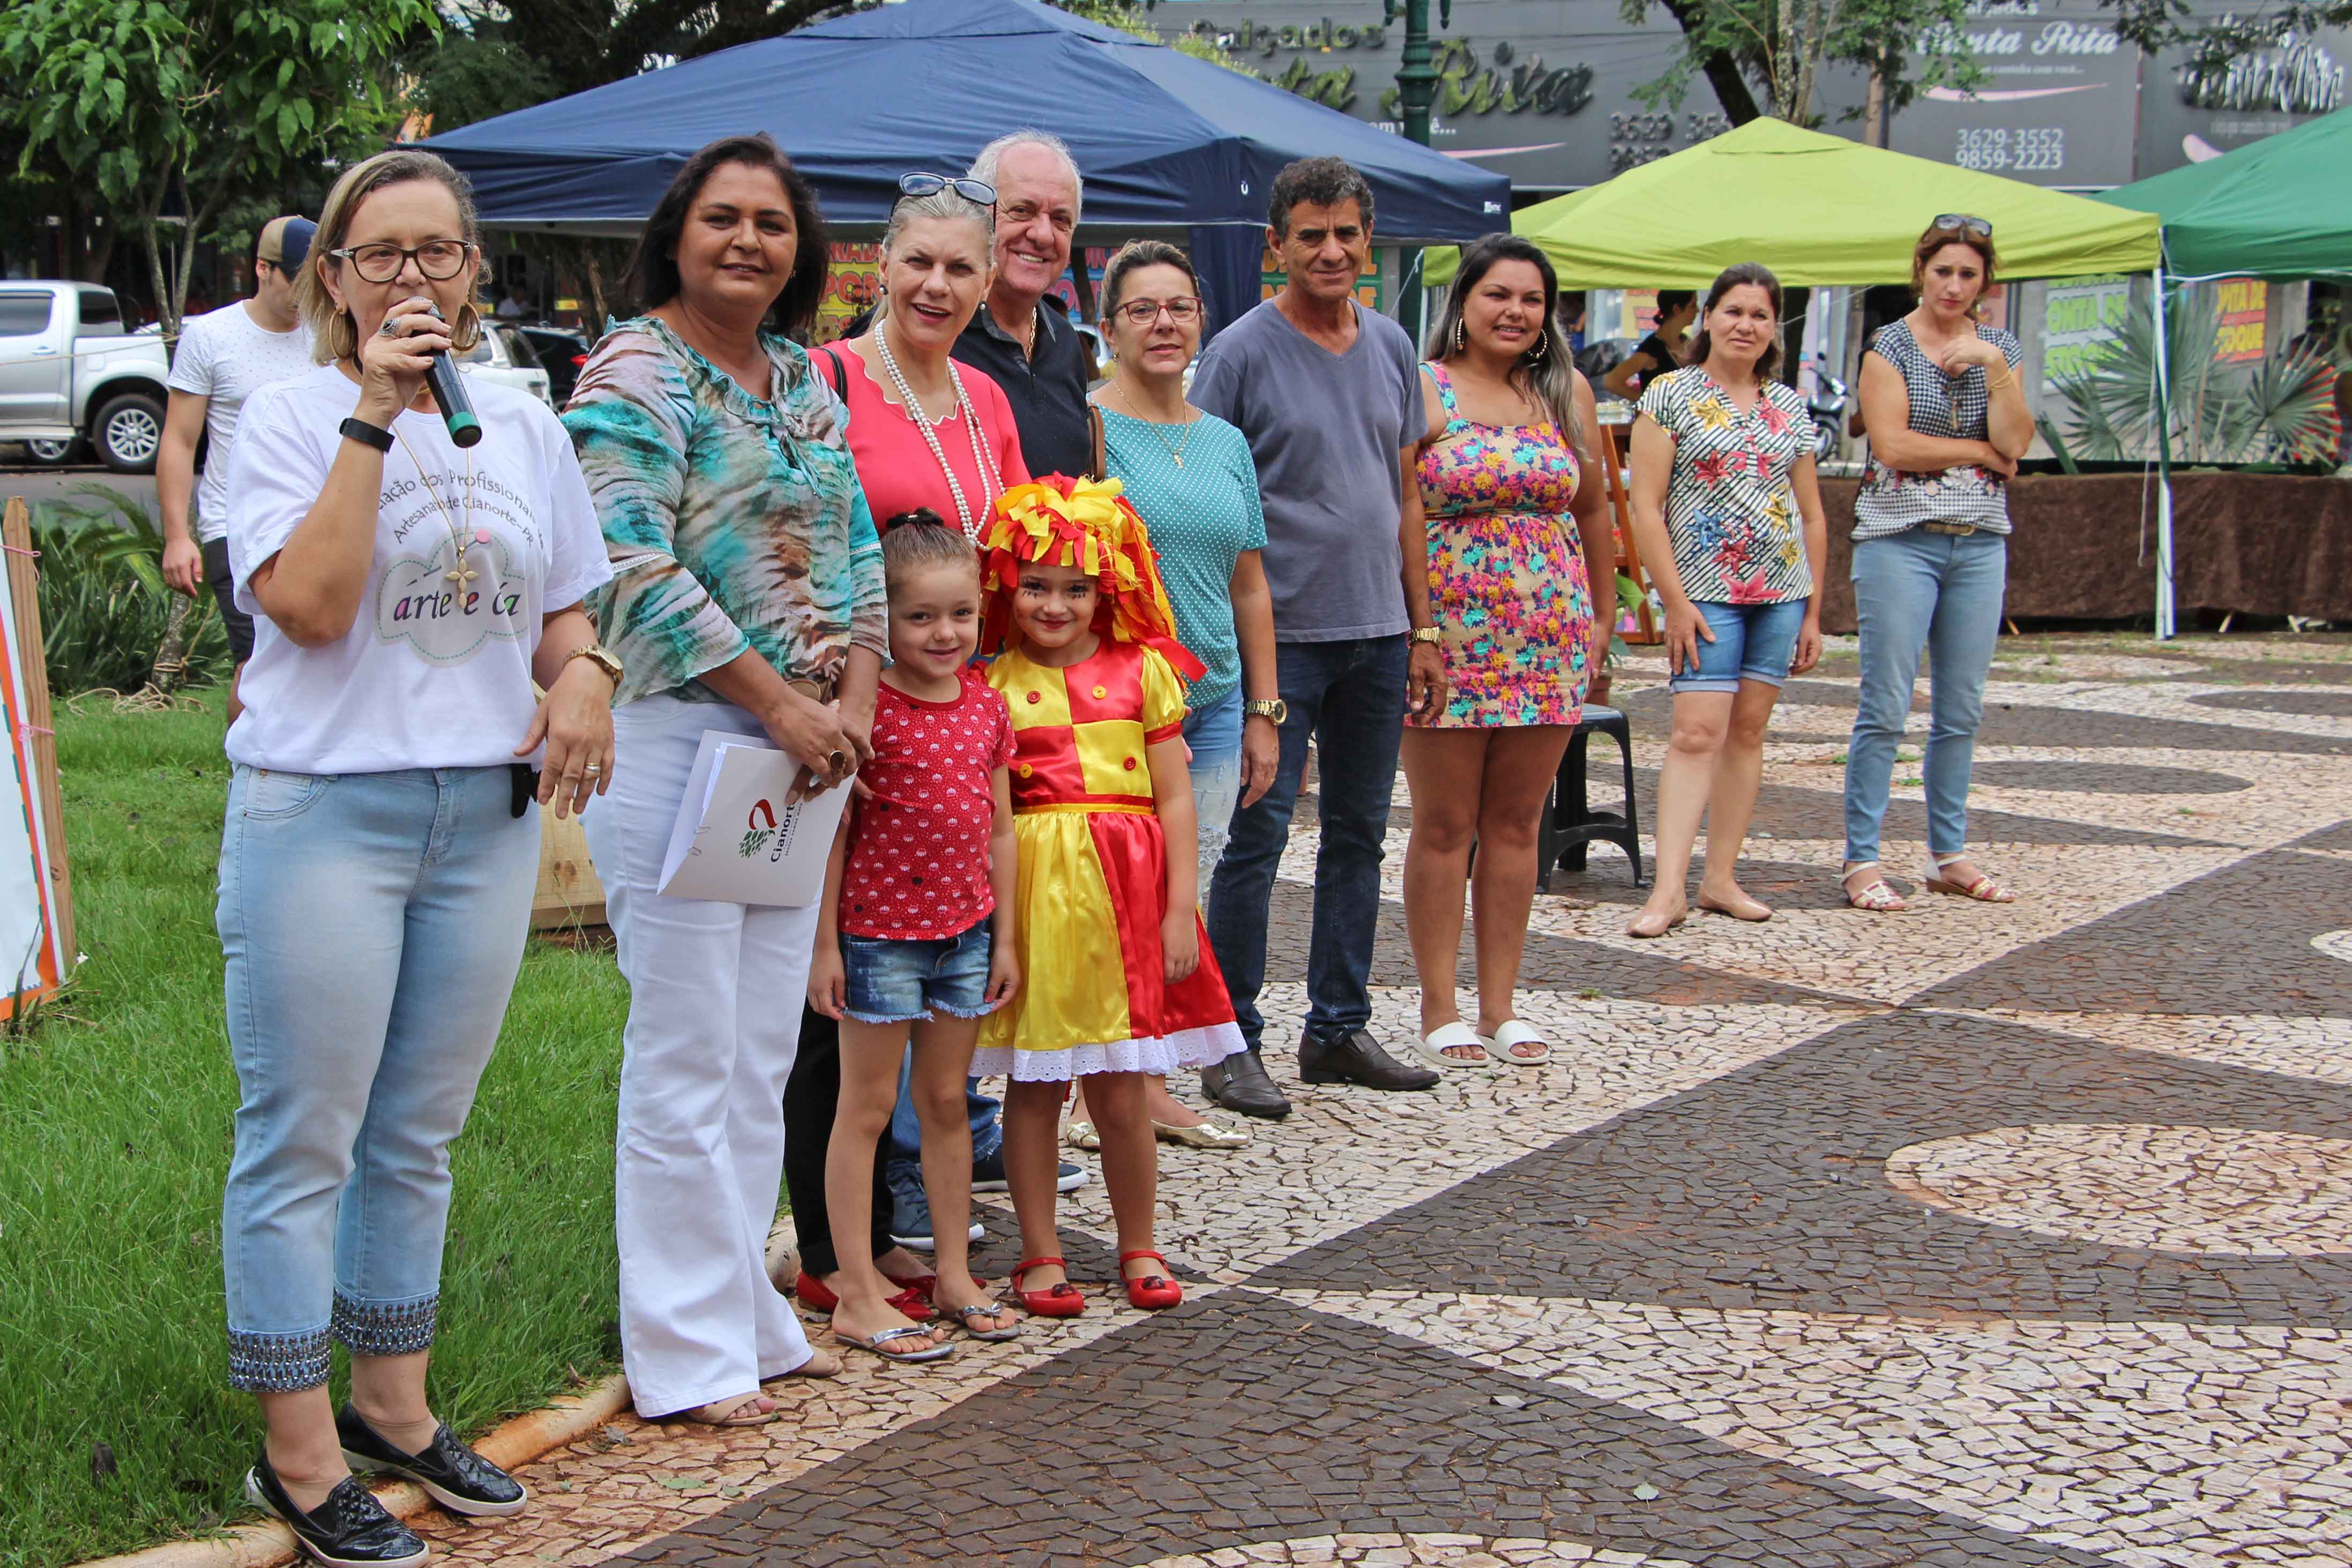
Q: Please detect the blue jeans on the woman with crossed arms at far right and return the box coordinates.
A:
[1846,529,2008,863]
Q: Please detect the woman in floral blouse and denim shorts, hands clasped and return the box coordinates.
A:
[1625,261,1830,936]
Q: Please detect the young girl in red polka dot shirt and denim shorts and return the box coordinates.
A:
[809,515,1021,1361]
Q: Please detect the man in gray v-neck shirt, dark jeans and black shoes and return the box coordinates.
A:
[1192,158,1444,1117]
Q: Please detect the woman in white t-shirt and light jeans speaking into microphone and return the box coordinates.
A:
[219,151,623,1568]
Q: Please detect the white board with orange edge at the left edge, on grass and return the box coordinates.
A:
[0,496,75,1018]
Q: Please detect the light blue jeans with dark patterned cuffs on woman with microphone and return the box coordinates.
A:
[216,764,539,1392]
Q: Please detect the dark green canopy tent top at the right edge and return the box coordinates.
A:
[2098,108,2352,280]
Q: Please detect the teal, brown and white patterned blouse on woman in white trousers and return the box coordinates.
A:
[564,315,889,703]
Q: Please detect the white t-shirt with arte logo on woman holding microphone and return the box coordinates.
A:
[228,364,611,773]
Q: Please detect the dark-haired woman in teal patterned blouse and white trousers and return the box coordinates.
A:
[564,136,889,1427]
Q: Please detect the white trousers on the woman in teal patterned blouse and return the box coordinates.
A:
[583,696,816,1417]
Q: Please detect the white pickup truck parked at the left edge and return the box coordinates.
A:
[0,278,171,473]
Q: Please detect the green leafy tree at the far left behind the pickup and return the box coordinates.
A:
[0,0,435,336]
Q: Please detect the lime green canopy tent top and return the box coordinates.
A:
[1425,120,2157,289]
